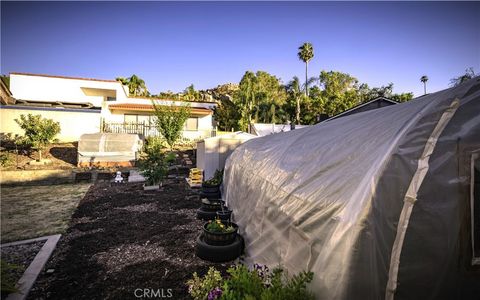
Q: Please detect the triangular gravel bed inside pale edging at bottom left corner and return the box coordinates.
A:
[1,241,45,299]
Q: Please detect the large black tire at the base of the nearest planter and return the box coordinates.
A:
[195,235,244,262]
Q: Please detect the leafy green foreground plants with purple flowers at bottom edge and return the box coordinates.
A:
[187,265,314,300]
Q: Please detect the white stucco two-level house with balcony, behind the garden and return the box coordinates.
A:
[0,73,217,141]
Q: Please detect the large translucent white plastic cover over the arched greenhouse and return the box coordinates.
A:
[224,77,480,299]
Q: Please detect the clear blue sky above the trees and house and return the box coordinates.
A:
[1,1,480,96]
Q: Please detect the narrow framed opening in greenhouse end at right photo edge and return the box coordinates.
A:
[470,152,480,265]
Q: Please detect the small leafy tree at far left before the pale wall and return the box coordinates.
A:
[15,114,60,161]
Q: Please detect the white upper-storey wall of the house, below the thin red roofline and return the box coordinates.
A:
[10,73,127,107]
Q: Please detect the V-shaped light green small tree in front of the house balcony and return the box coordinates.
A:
[152,100,190,150]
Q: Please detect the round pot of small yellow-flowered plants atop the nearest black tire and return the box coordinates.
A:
[203,218,238,246]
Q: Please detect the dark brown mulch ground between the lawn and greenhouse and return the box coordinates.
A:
[28,180,230,299]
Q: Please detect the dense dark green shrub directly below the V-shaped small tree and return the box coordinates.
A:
[138,139,168,185]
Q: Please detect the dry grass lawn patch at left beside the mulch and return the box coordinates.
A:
[1,184,90,243]
